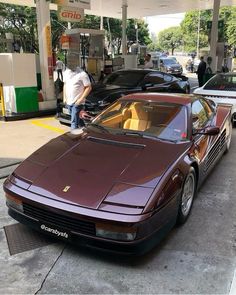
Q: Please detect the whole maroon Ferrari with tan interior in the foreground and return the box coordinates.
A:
[4,93,232,254]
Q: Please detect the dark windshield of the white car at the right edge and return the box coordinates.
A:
[204,74,236,91]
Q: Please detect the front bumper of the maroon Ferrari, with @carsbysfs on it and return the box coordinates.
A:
[4,179,178,255]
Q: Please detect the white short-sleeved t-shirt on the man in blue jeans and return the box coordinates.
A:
[63,68,91,105]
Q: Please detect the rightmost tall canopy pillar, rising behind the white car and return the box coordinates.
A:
[210,0,221,73]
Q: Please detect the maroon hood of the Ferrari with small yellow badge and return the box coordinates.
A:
[12,135,189,209]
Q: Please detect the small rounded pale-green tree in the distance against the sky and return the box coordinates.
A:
[158,27,183,55]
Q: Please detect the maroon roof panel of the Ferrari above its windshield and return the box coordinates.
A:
[120,92,195,105]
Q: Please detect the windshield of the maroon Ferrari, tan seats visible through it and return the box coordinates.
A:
[91,101,187,141]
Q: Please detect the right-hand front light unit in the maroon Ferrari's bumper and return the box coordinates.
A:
[96,224,136,241]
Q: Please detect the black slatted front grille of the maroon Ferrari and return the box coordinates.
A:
[23,203,96,236]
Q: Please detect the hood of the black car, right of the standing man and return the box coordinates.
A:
[86,84,133,104]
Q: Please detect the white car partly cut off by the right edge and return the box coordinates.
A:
[193,72,236,126]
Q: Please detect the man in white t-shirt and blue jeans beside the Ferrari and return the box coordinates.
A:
[63,67,92,133]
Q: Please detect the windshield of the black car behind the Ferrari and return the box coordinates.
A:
[102,71,146,87]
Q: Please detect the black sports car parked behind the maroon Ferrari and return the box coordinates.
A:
[57,69,190,124]
